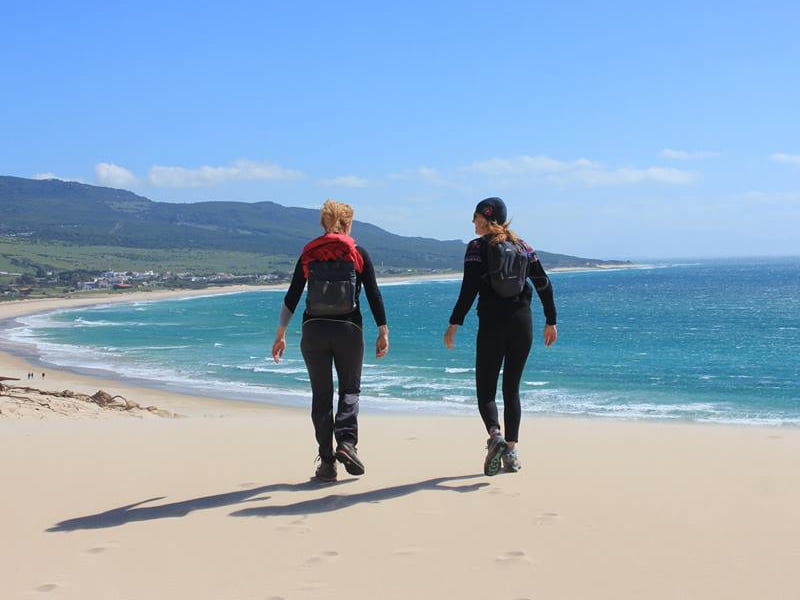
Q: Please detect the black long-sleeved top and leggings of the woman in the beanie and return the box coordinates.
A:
[450,237,556,442]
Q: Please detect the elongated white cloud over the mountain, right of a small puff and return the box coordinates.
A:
[147,160,303,188]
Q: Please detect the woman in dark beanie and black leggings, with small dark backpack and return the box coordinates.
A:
[444,198,558,475]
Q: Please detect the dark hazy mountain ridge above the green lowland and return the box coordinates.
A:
[0,176,620,269]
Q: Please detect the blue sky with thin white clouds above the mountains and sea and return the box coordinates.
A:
[0,1,800,258]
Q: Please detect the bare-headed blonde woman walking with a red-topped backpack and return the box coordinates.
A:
[272,200,389,481]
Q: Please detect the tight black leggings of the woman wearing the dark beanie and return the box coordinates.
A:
[475,307,533,442]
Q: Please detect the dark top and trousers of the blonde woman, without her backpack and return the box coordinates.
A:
[283,247,386,460]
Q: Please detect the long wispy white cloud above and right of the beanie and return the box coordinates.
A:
[467,156,696,186]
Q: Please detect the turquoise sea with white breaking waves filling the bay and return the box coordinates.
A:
[4,259,800,425]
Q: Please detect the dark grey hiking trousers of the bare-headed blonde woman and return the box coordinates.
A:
[300,319,364,459]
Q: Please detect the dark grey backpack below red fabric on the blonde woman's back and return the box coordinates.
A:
[306,260,356,317]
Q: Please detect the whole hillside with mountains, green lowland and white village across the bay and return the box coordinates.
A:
[0,176,632,297]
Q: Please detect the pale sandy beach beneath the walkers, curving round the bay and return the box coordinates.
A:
[0,287,800,600]
